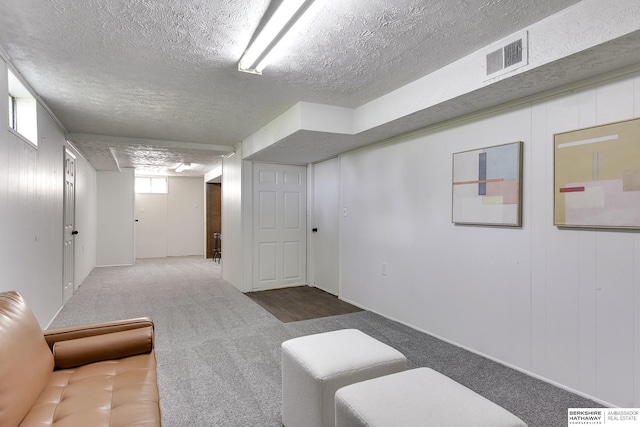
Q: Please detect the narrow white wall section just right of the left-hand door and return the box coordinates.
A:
[96,168,134,266]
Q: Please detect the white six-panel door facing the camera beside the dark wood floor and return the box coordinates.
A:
[252,163,307,290]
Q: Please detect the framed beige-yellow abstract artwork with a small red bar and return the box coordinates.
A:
[553,119,640,229]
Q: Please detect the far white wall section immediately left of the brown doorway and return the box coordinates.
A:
[167,177,205,256]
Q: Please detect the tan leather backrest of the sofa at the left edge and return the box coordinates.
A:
[0,292,53,426]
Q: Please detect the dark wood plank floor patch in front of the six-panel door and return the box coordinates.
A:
[245,286,362,323]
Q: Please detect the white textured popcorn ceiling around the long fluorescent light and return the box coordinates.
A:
[0,0,577,171]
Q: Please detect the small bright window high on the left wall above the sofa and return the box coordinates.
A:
[7,70,38,146]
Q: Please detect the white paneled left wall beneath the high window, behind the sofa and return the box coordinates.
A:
[0,55,95,327]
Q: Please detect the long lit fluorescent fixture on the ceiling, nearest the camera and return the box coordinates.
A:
[238,0,313,74]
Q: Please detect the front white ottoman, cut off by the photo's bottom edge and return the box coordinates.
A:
[336,368,527,427]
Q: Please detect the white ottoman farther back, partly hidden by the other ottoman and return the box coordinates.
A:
[282,329,407,427]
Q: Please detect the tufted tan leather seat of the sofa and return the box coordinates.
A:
[19,351,161,427]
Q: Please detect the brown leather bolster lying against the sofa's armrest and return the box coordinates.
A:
[53,327,153,369]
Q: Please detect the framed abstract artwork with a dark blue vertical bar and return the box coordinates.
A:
[451,141,522,227]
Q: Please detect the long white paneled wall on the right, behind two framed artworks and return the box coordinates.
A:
[340,73,640,407]
